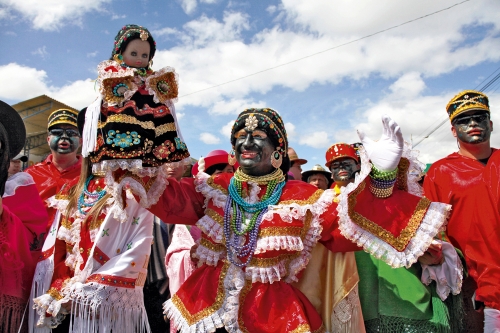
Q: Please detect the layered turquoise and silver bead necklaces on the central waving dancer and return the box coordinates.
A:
[224,169,285,267]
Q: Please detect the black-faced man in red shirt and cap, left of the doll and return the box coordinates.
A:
[26,109,82,228]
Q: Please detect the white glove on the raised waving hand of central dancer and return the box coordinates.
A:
[358,115,404,171]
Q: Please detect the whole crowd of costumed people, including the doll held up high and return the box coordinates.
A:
[0,25,500,333]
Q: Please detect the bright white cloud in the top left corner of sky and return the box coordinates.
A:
[0,0,111,31]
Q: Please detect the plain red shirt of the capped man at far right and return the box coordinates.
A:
[424,149,500,310]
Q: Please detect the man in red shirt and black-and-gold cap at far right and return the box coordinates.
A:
[424,90,500,332]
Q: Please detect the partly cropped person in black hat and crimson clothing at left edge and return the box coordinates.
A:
[0,101,47,333]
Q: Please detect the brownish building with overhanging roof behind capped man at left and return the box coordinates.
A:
[12,95,79,156]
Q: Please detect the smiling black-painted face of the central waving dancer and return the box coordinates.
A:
[234,128,275,176]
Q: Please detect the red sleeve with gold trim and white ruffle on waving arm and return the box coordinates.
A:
[337,145,451,268]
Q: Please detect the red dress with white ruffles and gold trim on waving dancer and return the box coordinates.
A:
[152,161,447,333]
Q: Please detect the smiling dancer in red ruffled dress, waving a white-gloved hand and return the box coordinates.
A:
[156,108,450,333]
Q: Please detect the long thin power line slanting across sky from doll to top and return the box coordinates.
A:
[180,0,470,97]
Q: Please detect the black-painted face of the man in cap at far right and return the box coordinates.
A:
[452,110,493,144]
